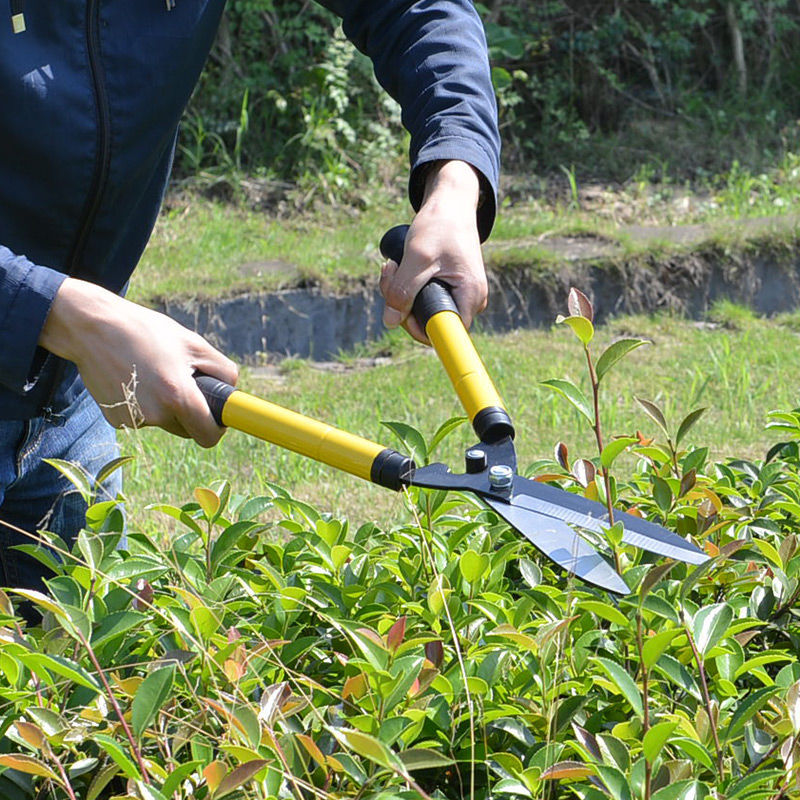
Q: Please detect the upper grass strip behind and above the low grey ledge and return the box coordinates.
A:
[130,145,800,303]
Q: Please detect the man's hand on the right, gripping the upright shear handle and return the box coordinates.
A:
[380,161,488,343]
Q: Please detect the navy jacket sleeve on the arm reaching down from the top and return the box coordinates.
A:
[318,0,500,241]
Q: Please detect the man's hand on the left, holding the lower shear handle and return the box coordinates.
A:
[39,278,238,447]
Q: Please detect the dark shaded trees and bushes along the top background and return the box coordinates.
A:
[181,0,800,189]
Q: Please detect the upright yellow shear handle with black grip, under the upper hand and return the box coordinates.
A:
[381,225,514,442]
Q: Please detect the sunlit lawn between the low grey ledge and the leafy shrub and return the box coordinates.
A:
[121,306,800,526]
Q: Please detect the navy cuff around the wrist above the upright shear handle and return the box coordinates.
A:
[408,136,499,242]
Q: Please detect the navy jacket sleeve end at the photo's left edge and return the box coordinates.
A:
[0,245,66,394]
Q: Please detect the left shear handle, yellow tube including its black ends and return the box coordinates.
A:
[195,374,414,490]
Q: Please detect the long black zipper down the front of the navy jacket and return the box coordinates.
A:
[42,0,111,419]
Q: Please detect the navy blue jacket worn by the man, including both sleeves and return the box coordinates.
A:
[0,0,499,419]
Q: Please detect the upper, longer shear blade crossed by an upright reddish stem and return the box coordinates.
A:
[511,475,708,564]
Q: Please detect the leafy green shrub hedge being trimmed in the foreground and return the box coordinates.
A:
[7,292,800,800]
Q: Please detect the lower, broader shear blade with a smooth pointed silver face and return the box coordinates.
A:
[483,497,630,594]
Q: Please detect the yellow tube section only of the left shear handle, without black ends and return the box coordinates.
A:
[222,391,385,480]
